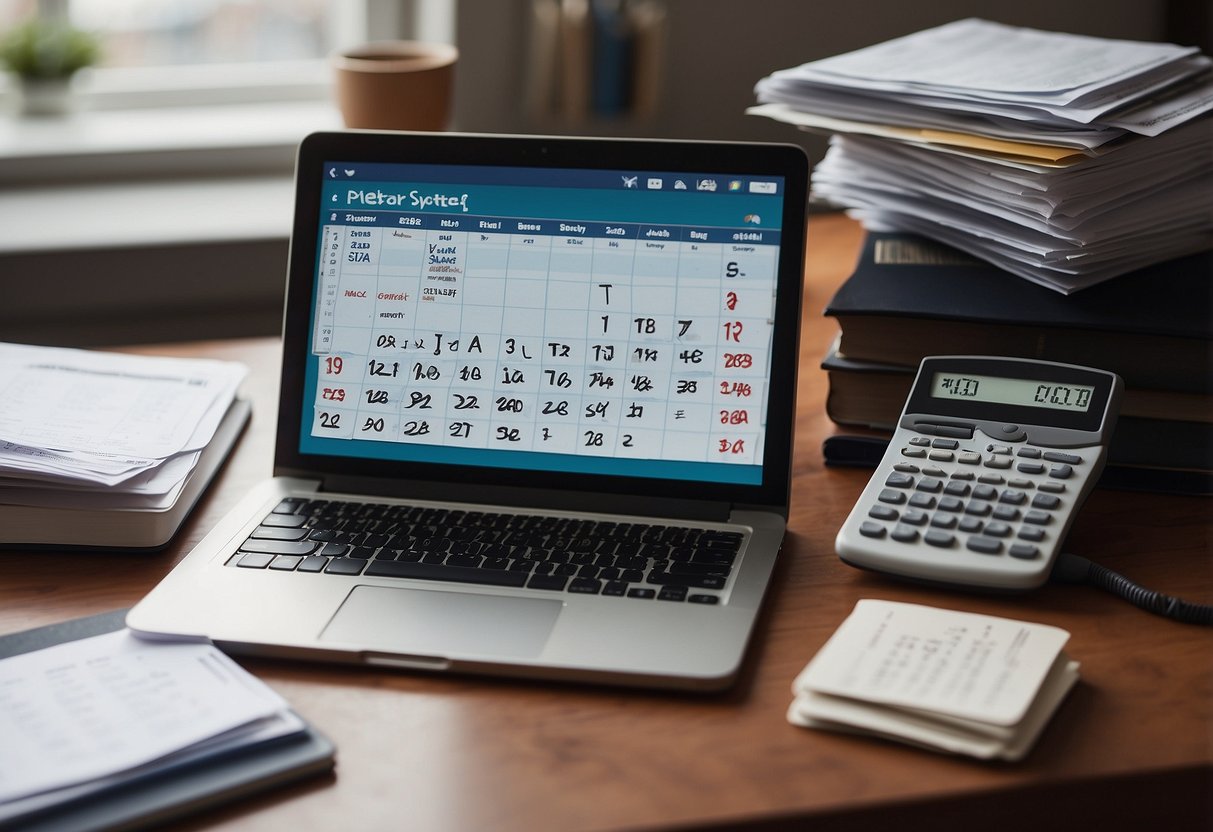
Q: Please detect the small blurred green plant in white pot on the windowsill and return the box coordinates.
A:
[0,18,101,115]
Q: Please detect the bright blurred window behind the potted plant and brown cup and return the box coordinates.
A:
[0,0,454,109]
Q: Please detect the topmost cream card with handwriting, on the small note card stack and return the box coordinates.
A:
[793,599,1070,725]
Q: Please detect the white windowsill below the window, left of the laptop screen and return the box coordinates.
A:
[0,102,341,253]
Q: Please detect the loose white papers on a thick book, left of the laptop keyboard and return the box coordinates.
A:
[0,344,249,548]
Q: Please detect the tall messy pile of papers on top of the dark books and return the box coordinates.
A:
[748,19,1213,294]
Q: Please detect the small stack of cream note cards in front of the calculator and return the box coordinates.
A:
[787,599,1078,760]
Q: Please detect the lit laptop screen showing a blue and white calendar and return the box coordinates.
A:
[277,134,803,511]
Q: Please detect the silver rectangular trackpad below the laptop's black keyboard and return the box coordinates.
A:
[320,586,564,657]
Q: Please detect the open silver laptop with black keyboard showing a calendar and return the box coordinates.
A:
[126,131,808,690]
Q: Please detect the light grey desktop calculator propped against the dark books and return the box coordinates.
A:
[835,355,1124,591]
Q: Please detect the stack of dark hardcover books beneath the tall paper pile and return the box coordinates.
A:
[822,232,1213,494]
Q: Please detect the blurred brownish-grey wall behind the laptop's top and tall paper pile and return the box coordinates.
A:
[456,0,1179,169]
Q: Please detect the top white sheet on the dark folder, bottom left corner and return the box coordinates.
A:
[0,629,287,803]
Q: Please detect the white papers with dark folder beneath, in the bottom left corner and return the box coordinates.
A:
[0,629,332,830]
